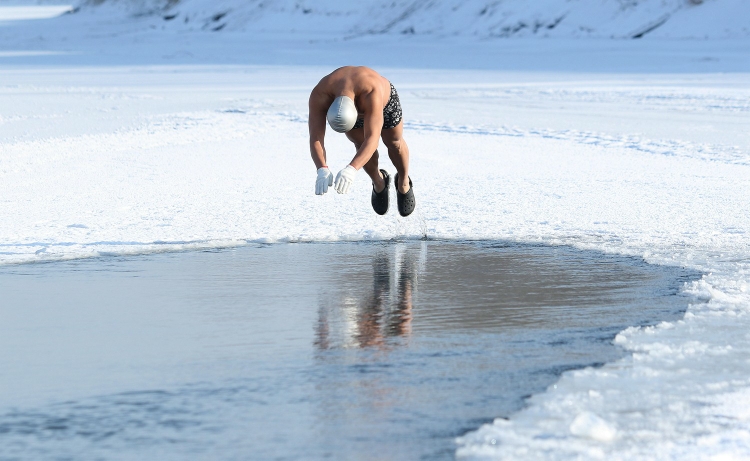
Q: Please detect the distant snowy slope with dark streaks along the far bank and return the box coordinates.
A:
[81,0,750,38]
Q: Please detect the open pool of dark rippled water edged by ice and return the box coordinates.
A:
[0,242,699,460]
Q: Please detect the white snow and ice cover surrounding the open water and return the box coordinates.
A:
[0,0,750,459]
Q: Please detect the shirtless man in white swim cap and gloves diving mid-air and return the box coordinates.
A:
[308,66,416,216]
